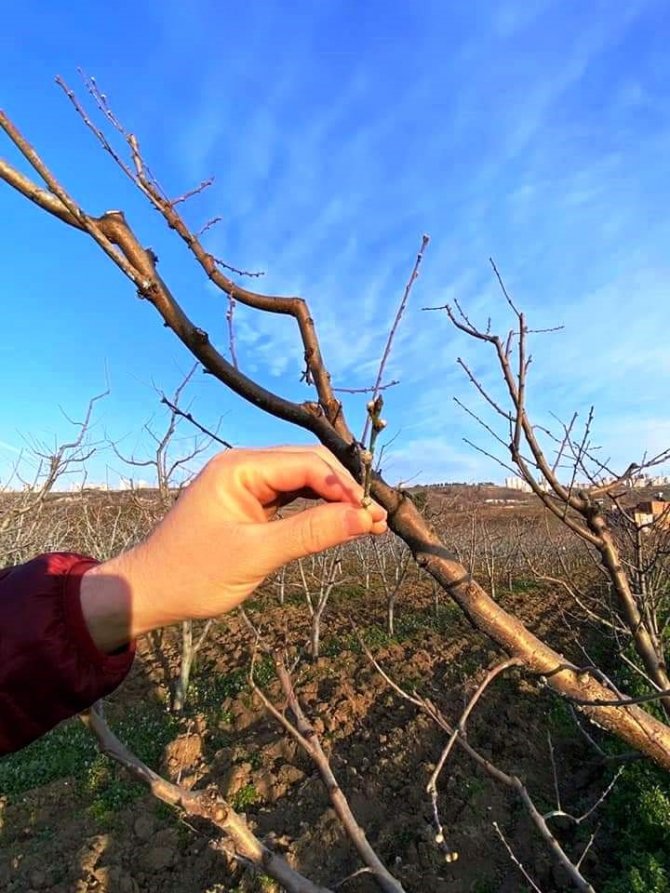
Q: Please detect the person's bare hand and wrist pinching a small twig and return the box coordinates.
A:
[81,447,386,651]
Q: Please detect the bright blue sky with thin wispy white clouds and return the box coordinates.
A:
[0,0,670,482]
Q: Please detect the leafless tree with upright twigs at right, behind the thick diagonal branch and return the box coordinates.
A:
[430,265,670,716]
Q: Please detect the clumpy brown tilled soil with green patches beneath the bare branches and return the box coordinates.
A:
[0,584,624,893]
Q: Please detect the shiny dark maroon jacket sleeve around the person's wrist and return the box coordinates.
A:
[0,552,135,755]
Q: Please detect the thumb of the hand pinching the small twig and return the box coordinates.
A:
[263,502,381,567]
